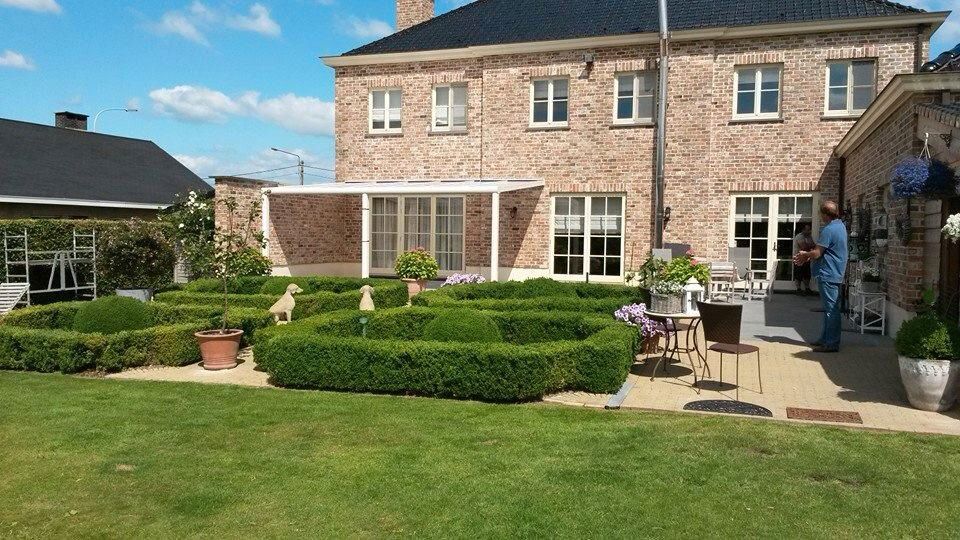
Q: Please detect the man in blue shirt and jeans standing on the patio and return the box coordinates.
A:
[793,201,848,353]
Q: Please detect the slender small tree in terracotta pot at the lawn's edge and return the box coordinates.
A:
[194,198,270,371]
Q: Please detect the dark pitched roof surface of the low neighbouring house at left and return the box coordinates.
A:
[0,118,211,205]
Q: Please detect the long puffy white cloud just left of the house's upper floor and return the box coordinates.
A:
[150,85,334,136]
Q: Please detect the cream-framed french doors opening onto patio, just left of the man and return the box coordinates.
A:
[730,193,820,289]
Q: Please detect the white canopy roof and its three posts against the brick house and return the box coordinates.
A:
[261,179,545,281]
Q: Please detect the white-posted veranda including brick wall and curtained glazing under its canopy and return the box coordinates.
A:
[260,179,544,281]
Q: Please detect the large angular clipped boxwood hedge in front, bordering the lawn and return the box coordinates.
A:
[254,308,636,402]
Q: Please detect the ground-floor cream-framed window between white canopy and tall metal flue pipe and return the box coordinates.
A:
[551,195,624,280]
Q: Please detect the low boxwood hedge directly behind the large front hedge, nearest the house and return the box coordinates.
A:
[412,278,650,314]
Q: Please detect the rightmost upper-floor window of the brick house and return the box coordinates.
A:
[825,60,877,116]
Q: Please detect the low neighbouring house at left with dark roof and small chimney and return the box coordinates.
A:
[0,112,210,219]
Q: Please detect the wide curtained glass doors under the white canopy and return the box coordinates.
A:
[370,196,464,275]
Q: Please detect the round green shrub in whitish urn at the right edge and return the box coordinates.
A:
[896,313,960,412]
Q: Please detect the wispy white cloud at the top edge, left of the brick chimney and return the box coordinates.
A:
[152,0,282,45]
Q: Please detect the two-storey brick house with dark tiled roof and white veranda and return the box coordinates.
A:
[217,0,948,292]
